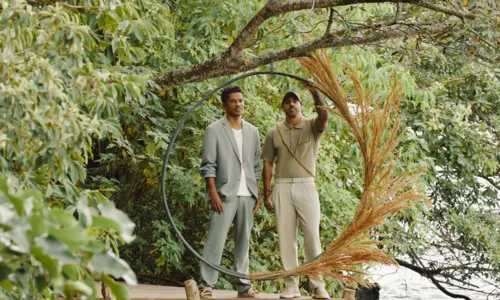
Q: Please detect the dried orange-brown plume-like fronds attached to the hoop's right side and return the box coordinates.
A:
[249,51,426,286]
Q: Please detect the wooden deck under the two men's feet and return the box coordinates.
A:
[99,284,342,300]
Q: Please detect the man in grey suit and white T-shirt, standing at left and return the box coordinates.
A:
[199,86,260,299]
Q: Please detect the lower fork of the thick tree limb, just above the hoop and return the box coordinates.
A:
[155,26,445,88]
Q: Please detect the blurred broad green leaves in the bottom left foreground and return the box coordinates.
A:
[0,179,137,299]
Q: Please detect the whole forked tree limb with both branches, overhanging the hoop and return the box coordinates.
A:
[155,0,474,88]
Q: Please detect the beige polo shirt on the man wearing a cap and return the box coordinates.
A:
[262,117,323,178]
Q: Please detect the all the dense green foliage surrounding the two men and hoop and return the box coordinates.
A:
[0,0,500,298]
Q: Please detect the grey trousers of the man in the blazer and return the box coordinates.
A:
[198,196,255,293]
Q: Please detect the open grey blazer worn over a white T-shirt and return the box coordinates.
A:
[200,116,260,201]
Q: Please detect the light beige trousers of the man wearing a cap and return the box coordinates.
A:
[272,177,325,289]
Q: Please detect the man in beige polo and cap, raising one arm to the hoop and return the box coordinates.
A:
[262,87,330,299]
